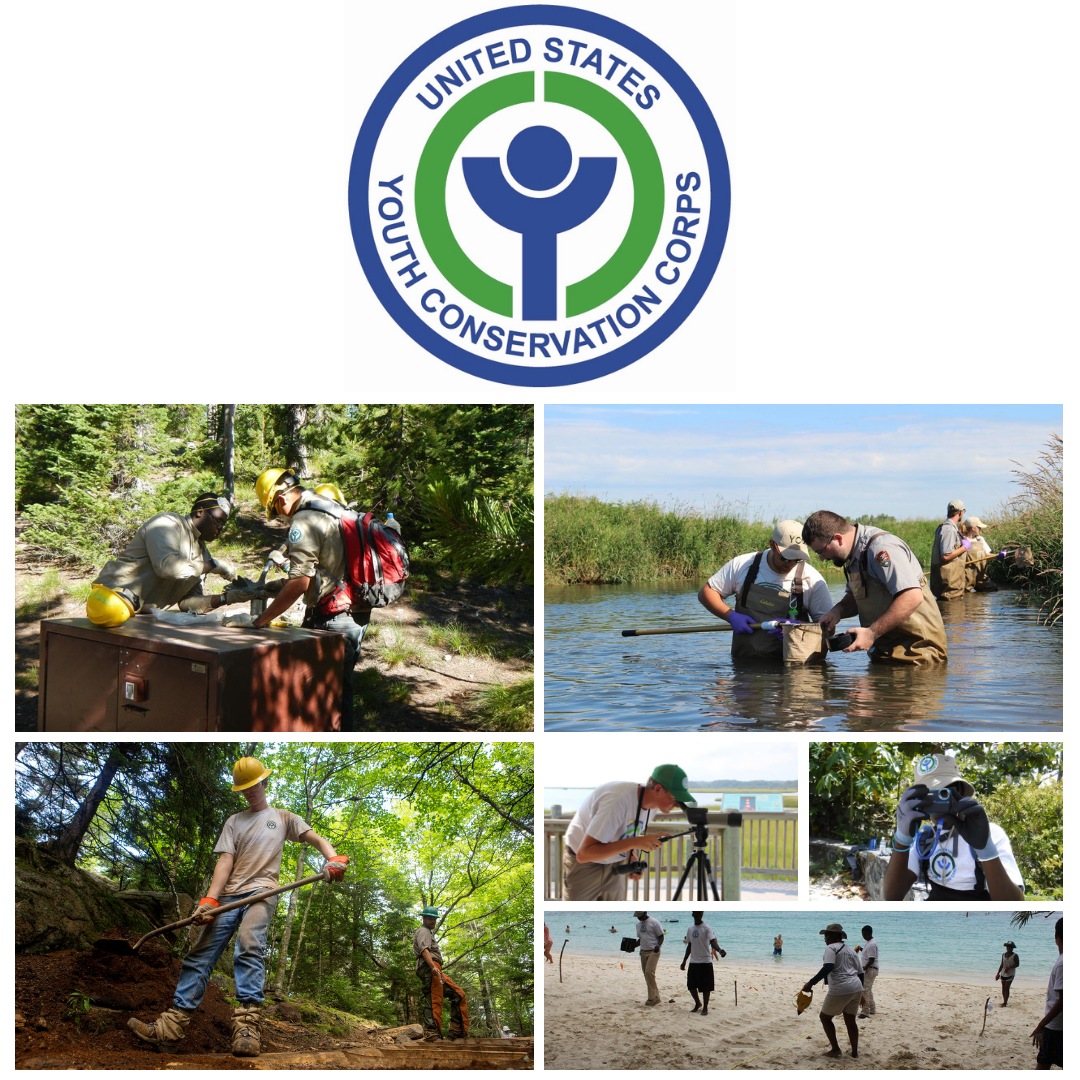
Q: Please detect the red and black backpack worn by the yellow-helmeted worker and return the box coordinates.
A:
[302,498,408,618]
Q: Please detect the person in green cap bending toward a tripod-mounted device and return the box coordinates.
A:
[563,765,696,901]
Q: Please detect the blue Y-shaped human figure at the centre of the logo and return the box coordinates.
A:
[461,125,616,320]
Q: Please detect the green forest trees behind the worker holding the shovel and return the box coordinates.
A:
[16,742,534,1035]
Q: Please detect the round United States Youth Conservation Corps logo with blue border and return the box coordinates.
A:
[349,4,731,387]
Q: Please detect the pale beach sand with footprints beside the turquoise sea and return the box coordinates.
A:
[543,959,1045,1069]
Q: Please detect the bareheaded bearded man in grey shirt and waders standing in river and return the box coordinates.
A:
[802,510,948,665]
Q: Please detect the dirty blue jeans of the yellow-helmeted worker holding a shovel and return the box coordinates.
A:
[173,889,278,1011]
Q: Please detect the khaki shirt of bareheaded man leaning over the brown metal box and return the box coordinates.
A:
[94,512,211,607]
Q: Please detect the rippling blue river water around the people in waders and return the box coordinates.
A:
[544,581,1063,733]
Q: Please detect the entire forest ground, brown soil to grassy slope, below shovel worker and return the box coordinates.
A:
[15,932,532,1069]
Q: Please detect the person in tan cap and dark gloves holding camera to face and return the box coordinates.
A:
[881,754,1024,902]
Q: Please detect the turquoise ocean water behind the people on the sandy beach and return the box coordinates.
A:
[544,904,1062,986]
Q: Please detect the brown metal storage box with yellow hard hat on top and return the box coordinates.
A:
[38,616,345,732]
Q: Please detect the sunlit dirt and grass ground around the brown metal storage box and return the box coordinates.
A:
[15,517,534,732]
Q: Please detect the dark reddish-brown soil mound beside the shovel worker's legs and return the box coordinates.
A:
[15,933,232,1068]
